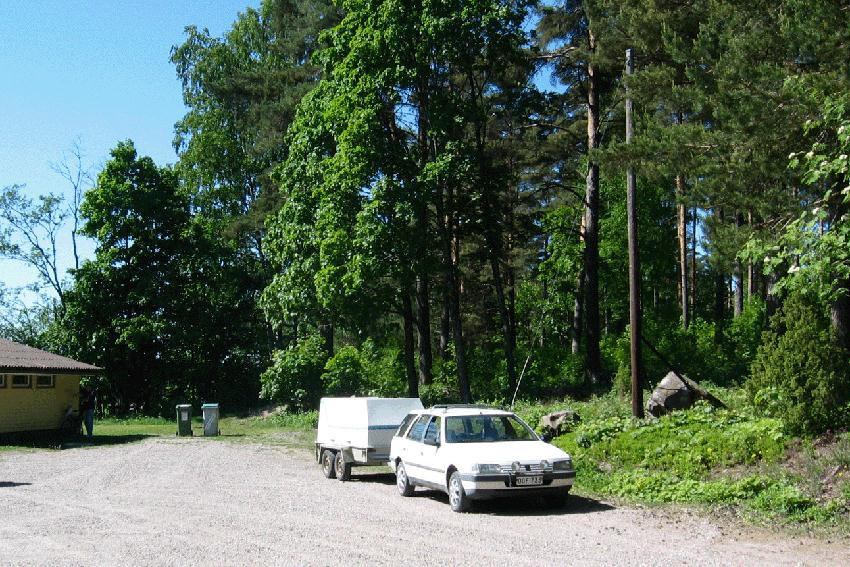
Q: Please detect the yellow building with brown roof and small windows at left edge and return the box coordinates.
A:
[0,339,101,433]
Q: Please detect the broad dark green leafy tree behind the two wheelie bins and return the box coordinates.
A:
[61,142,261,414]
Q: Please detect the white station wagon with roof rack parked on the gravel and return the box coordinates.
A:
[388,405,576,512]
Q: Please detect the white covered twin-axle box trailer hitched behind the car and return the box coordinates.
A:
[316,398,422,480]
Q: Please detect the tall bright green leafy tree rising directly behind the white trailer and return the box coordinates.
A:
[265,2,523,400]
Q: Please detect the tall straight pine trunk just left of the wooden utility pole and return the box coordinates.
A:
[584,32,602,384]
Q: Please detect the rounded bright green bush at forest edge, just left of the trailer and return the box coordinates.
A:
[260,335,327,411]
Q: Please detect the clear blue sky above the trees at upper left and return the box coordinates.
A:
[0,0,259,300]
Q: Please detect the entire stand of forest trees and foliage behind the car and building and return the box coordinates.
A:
[0,0,850,438]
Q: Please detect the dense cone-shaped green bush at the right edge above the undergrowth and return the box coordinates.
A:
[747,294,850,435]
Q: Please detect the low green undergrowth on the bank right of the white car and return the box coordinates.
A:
[516,389,850,528]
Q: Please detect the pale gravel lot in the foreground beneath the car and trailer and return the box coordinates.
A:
[0,438,850,567]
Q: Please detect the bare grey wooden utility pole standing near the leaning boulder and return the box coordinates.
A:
[626,49,643,418]
